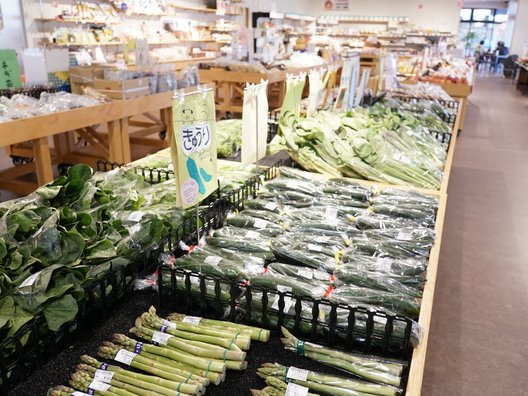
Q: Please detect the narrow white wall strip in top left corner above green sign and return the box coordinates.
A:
[0,0,26,64]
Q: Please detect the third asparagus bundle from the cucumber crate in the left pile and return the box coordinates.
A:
[131,318,247,370]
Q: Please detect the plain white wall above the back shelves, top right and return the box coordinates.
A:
[309,0,460,31]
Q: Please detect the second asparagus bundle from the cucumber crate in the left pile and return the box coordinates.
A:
[141,307,251,351]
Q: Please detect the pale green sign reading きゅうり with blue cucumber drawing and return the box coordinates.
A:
[171,89,218,208]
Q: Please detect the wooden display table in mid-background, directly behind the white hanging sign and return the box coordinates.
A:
[199,68,286,113]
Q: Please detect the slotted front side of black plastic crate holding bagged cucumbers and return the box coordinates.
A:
[158,266,413,360]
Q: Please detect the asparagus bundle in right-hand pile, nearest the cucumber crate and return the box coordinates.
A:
[281,327,403,386]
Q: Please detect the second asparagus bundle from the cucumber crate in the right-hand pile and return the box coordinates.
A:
[257,363,399,396]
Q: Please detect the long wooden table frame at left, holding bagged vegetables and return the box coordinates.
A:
[0,92,172,194]
